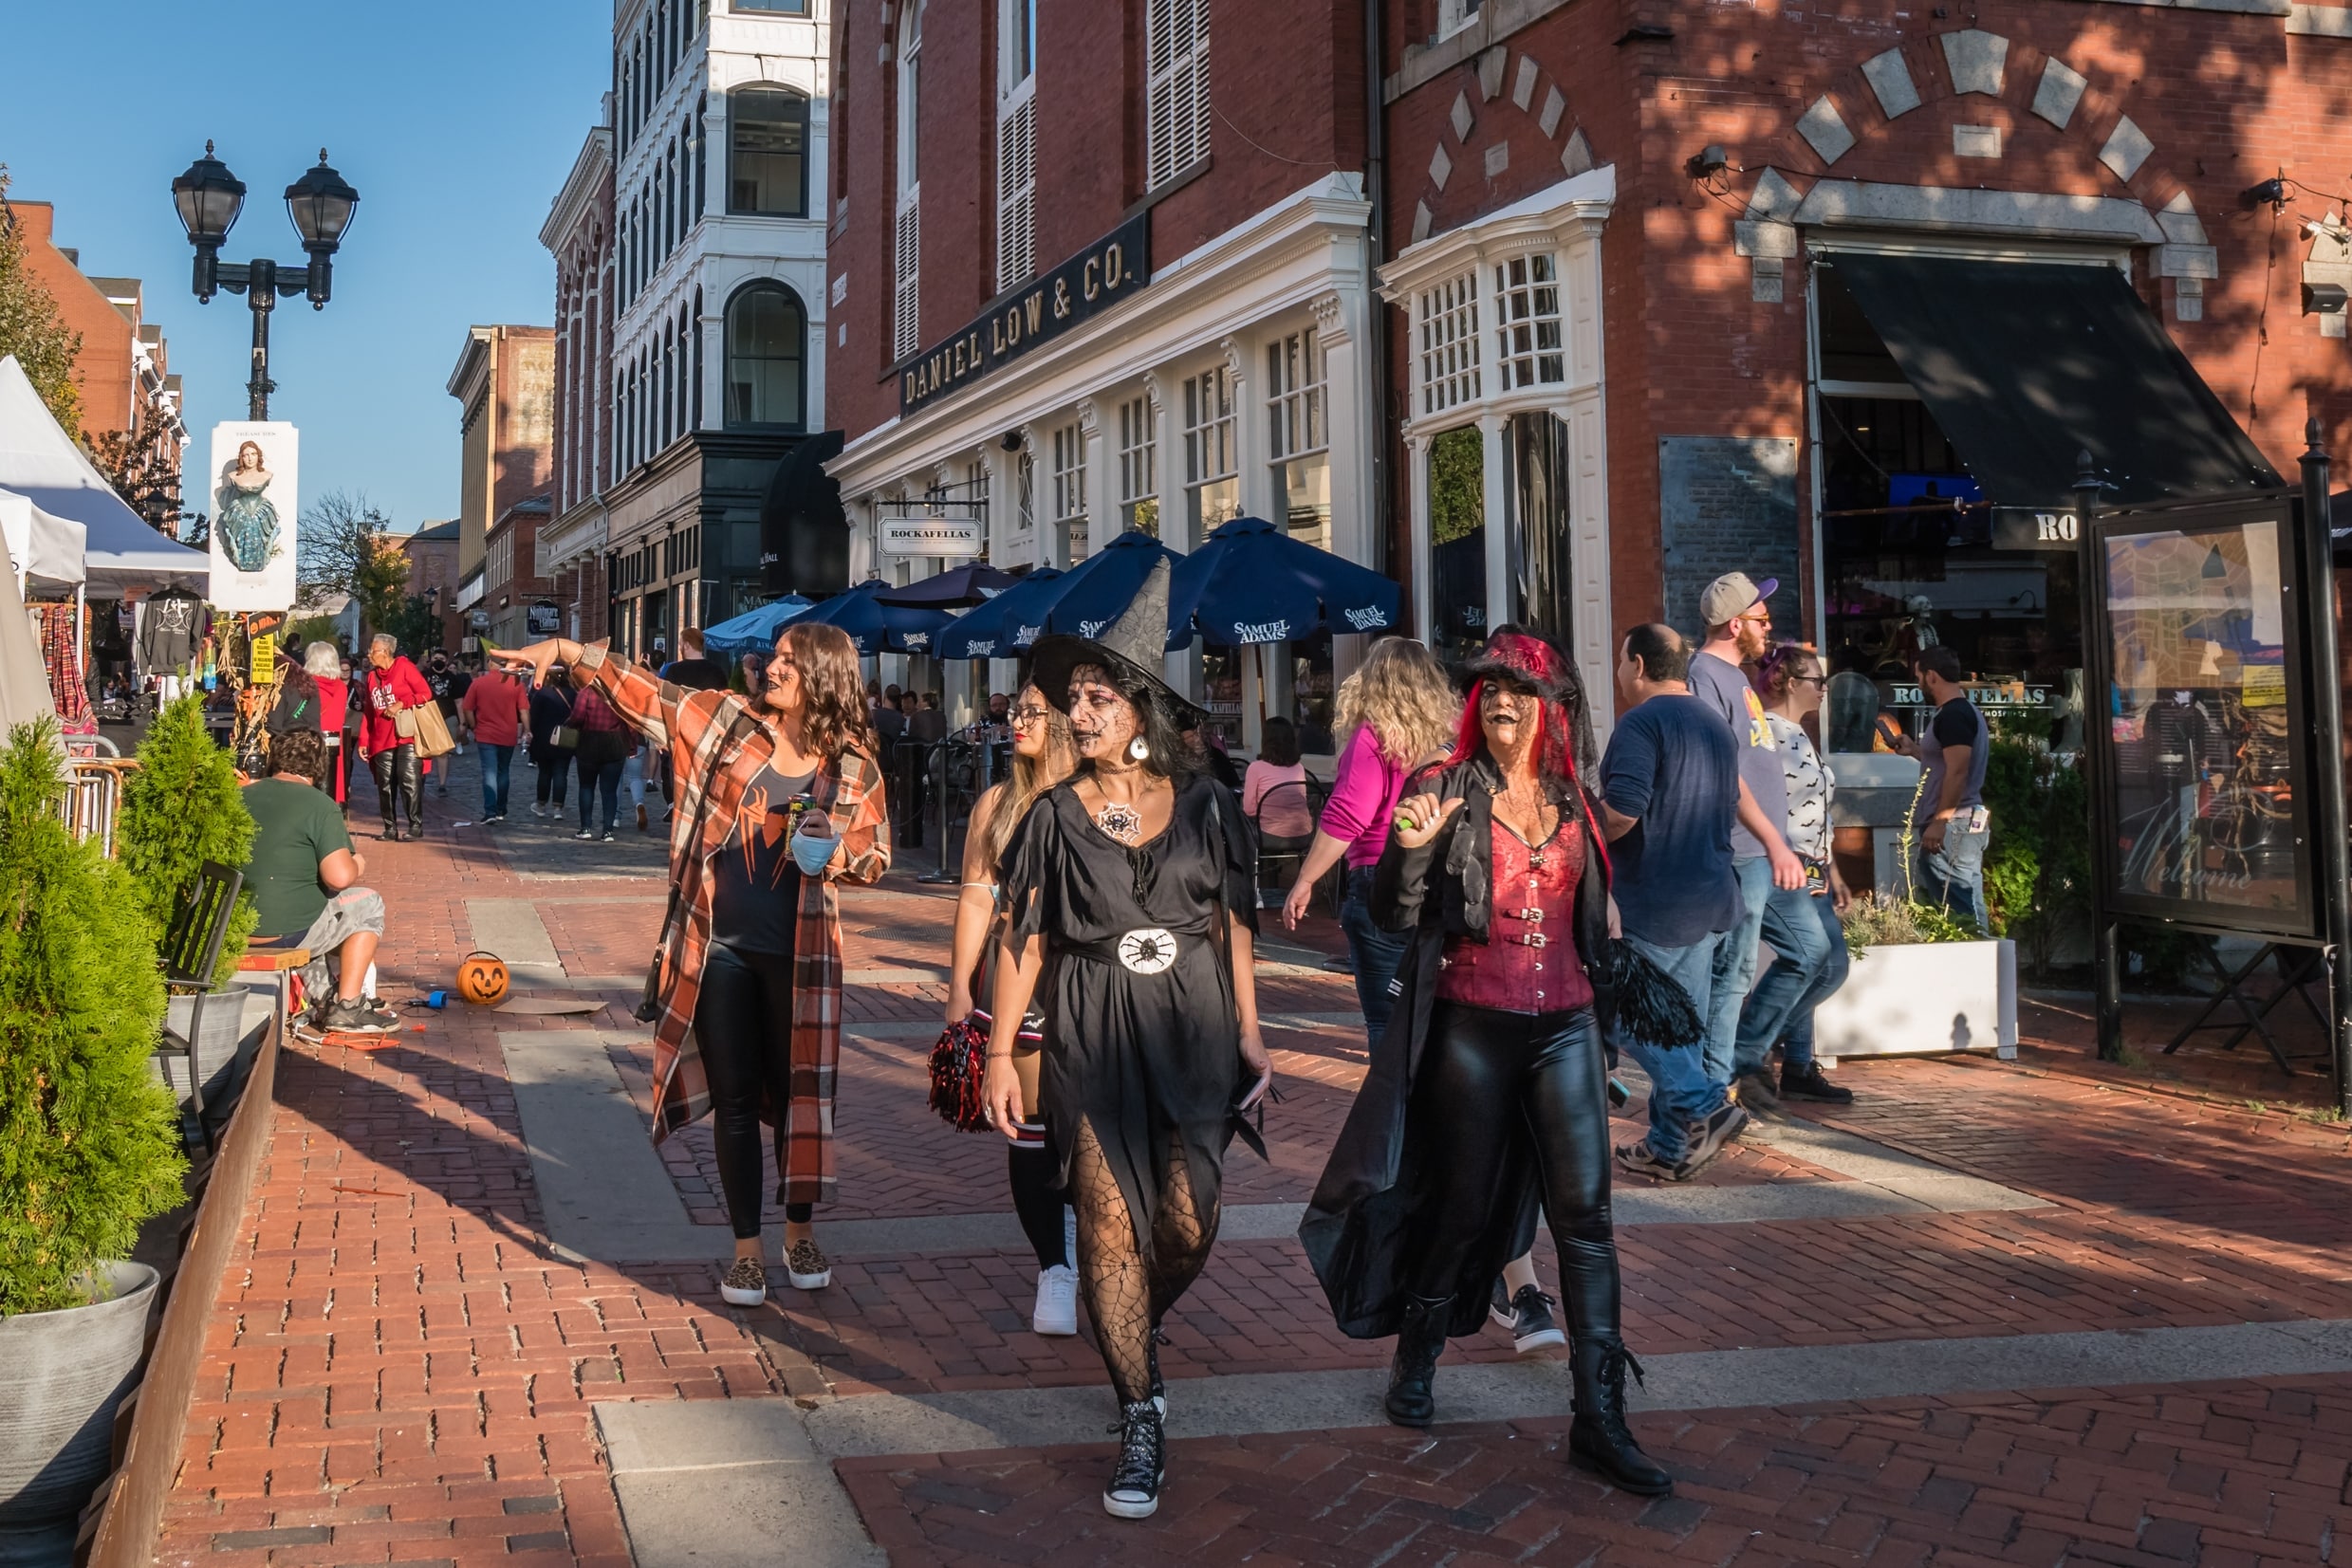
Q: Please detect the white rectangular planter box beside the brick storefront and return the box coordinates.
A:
[1813,940,2018,1058]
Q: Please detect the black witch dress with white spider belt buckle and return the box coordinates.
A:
[1002,773,1258,1250]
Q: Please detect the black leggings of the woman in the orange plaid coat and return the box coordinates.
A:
[694,943,814,1242]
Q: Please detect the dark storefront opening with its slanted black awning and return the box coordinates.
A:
[1811,249,2277,750]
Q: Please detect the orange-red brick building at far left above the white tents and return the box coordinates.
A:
[5,200,188,526]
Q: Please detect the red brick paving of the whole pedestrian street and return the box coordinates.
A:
[162,759,2352,1568]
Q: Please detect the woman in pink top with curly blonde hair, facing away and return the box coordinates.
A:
[1282,637,1460,1043]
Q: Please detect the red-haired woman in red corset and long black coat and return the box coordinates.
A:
[1301,628,1673,1495]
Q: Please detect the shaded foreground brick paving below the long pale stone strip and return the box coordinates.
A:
[838,1377,2352,1568]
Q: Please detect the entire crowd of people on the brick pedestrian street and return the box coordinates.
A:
[229,549,1990,1519]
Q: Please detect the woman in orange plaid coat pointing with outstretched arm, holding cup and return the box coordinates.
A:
[496,625,889,1307]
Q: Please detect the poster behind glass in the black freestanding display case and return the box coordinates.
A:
[2093,498,2319,935]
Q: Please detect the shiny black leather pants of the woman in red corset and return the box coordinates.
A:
[1411,1002,1619,1340]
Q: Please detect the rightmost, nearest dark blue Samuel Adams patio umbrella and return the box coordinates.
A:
[1171,517,1401,647]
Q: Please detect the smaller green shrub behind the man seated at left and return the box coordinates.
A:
[115,693,254,985]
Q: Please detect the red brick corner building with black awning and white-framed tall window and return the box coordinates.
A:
[1383,0,2352,738]
